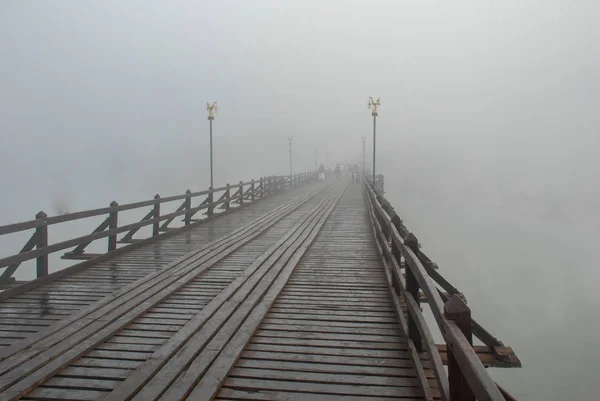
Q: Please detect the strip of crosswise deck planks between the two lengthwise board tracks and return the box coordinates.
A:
[11,183,338,400]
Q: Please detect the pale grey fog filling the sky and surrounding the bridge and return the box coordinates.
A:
[0,0,600,400]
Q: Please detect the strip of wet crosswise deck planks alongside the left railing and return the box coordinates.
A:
[0,187,316,347]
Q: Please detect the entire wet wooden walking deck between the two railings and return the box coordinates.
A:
[0,181,516,401]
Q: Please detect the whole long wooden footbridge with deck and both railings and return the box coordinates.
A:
[0,173,520,401]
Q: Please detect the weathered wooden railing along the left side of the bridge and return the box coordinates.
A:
[0,172,316,285]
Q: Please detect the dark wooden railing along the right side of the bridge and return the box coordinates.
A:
[364,178,521,401]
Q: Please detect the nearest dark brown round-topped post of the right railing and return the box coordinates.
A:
[444,294,475,401]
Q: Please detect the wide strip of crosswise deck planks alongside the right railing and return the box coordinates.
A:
[216,185,423,401]
